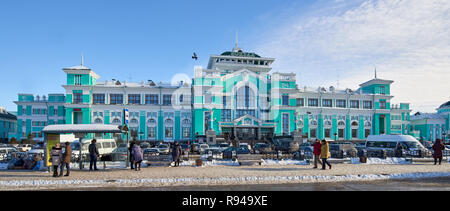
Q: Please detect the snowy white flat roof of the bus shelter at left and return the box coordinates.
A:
[42,124,122,134]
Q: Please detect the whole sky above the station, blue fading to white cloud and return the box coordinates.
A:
[0,0,450,111]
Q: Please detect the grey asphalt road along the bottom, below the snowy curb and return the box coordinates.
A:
[58,177,450,191]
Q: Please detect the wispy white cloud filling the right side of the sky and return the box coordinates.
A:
[257,0,450,112]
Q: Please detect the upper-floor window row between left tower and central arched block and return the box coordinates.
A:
[91,94,189,105]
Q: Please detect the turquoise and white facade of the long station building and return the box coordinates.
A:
[16,46,442,142]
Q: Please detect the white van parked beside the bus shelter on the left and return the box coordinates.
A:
[71,139,117,156]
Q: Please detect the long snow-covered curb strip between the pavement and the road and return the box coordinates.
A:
[0,172,450,187]
